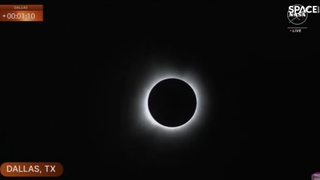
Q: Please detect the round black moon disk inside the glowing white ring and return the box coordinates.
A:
[148,79,197,127]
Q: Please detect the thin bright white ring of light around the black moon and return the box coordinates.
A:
[146,78,198,129]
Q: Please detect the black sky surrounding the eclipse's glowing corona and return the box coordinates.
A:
[0,1,319,179]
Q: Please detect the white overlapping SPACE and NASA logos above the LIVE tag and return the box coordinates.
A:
[287,4,320,25]
